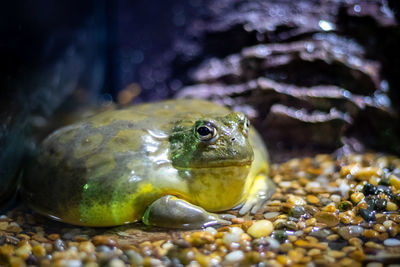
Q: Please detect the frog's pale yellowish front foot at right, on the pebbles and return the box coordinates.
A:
[239,174,276,215]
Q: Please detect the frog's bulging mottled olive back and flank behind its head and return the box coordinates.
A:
[22,100,230,226]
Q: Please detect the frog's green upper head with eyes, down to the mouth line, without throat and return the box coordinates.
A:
[170,112,253,169]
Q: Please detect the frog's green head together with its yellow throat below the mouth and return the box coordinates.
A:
[169,112,253,211]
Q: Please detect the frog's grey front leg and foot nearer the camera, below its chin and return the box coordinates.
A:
[142,195,235,229]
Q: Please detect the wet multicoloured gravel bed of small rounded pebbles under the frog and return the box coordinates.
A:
[0,153,400,267]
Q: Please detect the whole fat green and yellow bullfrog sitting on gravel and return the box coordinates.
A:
[21,99,274,228]
